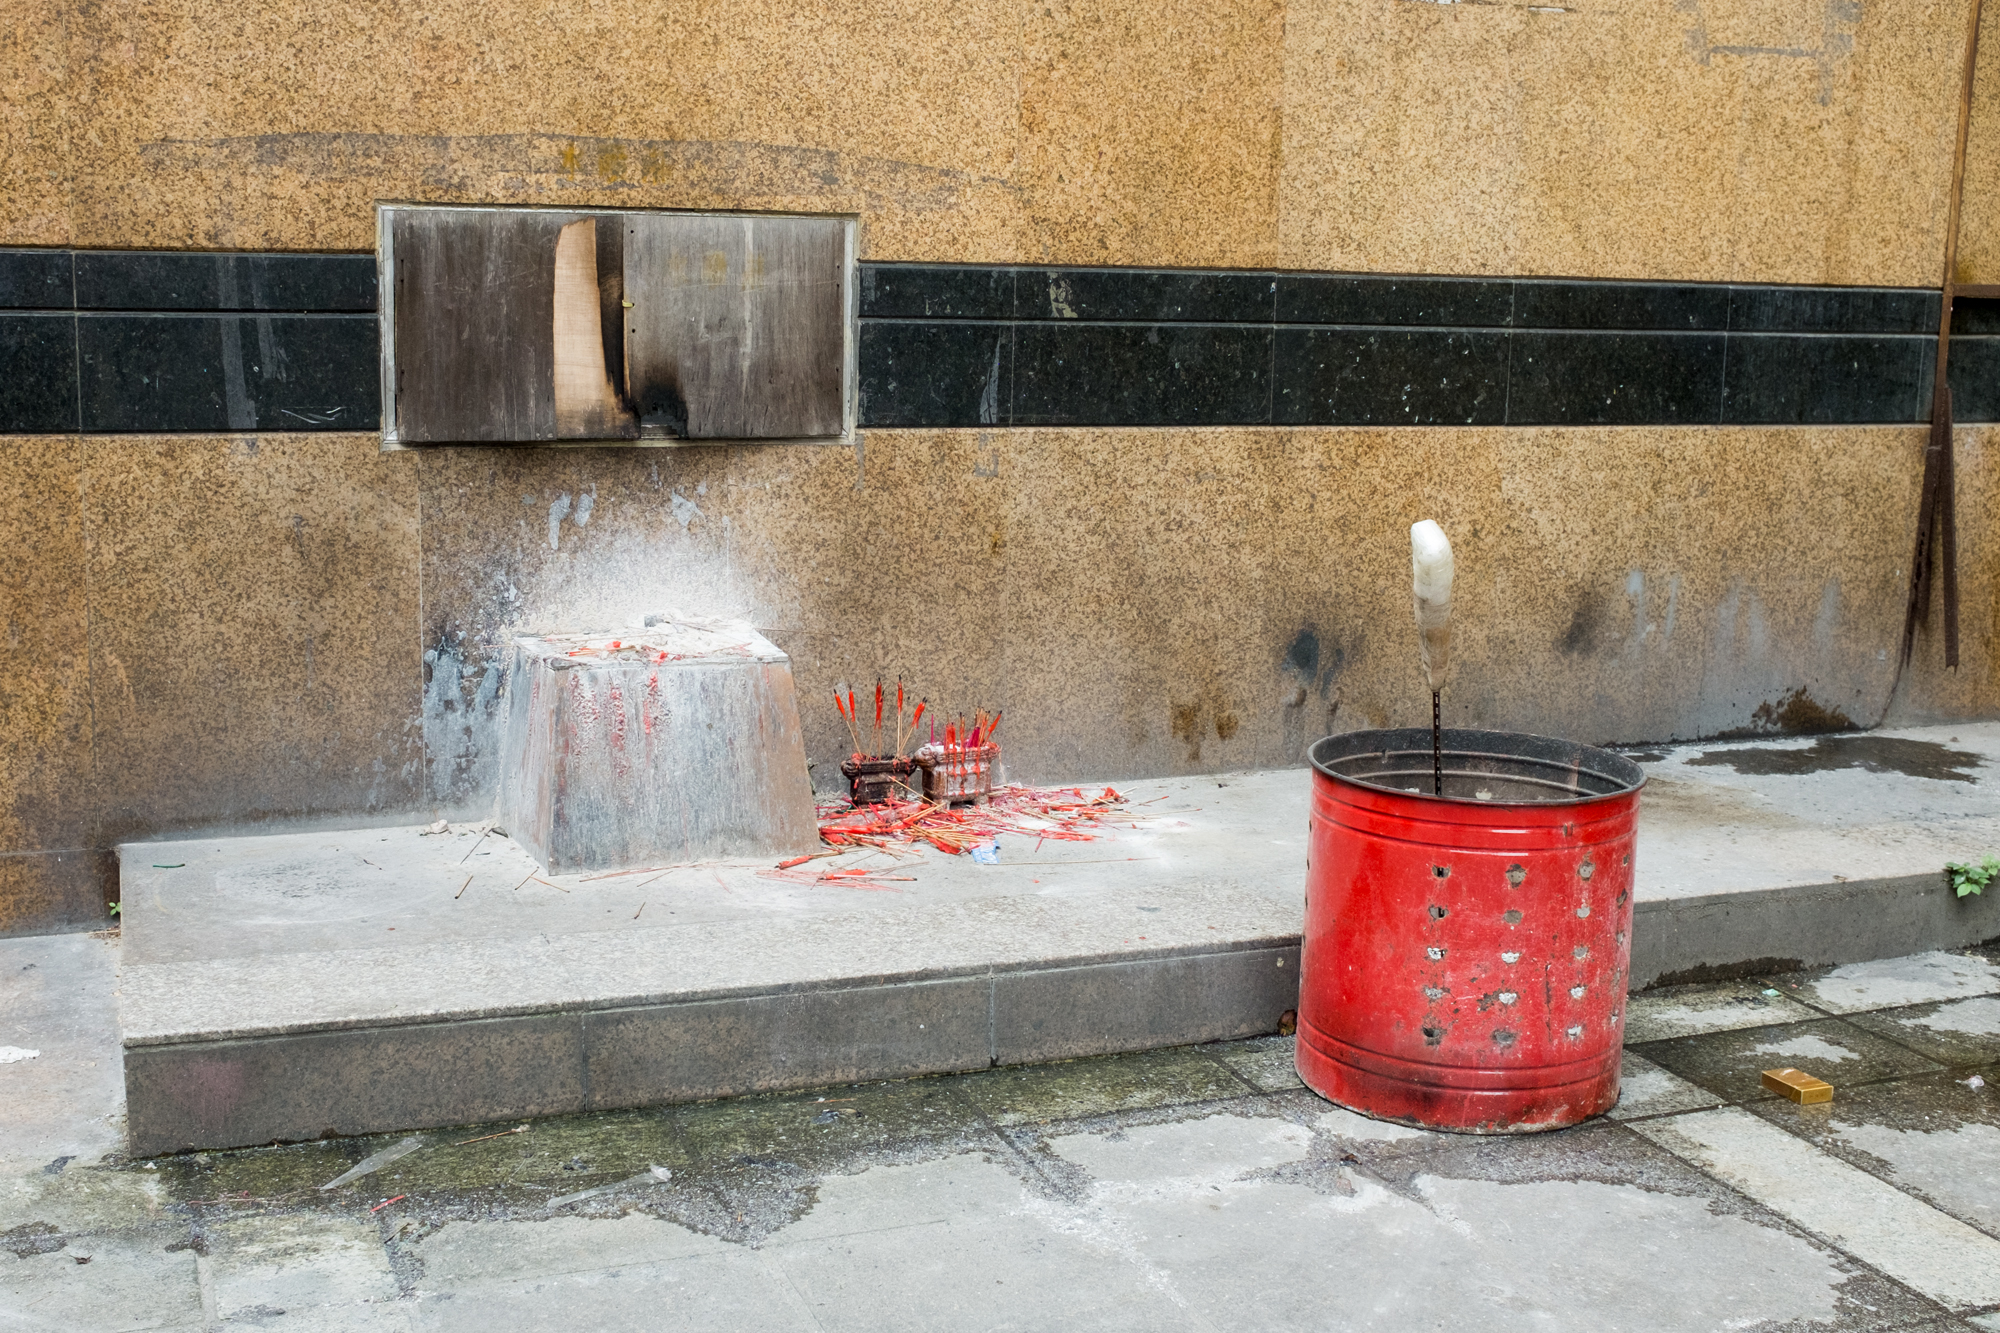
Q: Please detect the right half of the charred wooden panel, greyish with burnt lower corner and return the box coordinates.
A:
[624,214,846,440]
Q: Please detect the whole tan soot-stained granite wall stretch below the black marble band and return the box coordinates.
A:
[0,426,2000,931]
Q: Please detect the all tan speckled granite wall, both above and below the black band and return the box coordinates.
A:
[0,0,2000,933]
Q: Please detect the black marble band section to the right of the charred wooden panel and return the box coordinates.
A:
[860,264,2000,426]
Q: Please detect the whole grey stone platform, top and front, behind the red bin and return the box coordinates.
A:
[120,725,2000,1155]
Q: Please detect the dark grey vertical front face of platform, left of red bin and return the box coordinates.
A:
[124,945,1298,1157]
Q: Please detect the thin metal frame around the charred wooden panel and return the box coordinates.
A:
[376,200,860,452]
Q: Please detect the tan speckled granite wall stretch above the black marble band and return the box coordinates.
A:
[0,0,1996,284]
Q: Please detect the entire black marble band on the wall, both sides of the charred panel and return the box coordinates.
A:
[0,250,2000,432]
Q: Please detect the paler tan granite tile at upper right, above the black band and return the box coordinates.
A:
[1280,0,1964,284]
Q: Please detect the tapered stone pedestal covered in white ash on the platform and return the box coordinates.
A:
[500,620,818,875]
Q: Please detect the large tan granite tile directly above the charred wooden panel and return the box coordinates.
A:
[60,0,1020,258]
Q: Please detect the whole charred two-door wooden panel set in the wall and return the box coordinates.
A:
[382,208,848,444]
